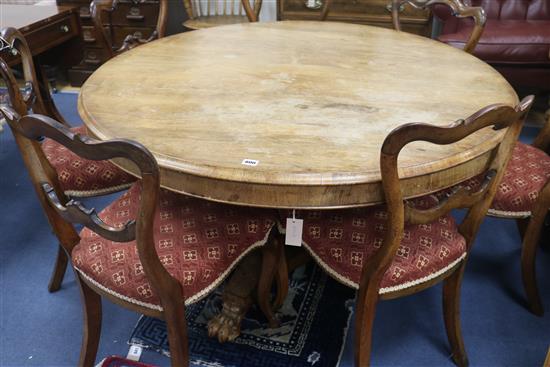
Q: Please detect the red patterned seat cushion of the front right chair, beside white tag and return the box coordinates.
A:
[280,197,466,293]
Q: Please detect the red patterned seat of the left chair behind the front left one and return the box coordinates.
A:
[42,126,136,197]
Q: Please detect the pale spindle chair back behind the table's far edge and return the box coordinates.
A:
[183,0,262,22]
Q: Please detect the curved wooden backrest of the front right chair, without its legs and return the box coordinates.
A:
[361,96,533,292]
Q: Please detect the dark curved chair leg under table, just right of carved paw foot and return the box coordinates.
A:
[256,236,283,328]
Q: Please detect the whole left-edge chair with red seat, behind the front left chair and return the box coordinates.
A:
[0,27,135,292]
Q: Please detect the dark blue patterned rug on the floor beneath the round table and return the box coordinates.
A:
[128,265,355,367]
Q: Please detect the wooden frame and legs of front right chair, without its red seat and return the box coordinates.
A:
[355,96,533,366]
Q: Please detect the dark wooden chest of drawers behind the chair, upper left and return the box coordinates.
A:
[57,0,159,86]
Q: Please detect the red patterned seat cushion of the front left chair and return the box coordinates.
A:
[72,184,275,309]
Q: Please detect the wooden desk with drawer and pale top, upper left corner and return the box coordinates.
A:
[0,4,80,65]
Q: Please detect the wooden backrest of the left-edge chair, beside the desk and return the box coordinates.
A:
[0,27,68,125]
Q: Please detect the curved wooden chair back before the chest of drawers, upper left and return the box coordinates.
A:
[90,0,168,58]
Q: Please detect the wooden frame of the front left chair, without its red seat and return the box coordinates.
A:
[0,105,283,367]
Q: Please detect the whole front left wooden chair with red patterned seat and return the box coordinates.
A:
[1,107,280,367]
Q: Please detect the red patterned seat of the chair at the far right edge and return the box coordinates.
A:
[463,142,550,218]
